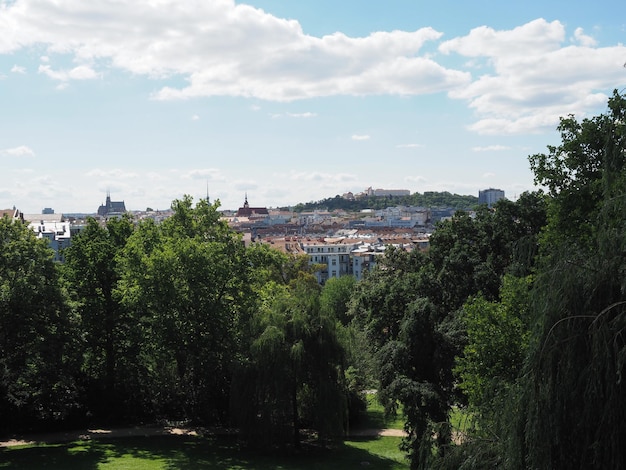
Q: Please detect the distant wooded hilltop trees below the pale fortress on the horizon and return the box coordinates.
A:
[285,191,478,212]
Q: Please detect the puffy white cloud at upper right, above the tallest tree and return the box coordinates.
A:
[439,19,626,135]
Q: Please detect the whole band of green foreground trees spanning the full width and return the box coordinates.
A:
[0,92,626,470]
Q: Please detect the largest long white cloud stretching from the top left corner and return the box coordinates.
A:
[0,0,470,101]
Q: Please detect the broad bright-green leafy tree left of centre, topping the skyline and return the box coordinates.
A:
[117,197,249,423]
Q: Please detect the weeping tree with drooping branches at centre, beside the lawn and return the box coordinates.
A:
[233,248,346,448]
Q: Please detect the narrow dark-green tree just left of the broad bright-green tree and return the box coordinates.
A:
[63,216,133,419]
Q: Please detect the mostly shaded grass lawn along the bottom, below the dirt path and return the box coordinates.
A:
[0,436,408,470]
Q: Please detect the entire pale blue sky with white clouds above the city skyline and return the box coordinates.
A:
[0,0,626,214]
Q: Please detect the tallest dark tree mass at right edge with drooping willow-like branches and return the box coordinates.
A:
[512,92,626,468]
